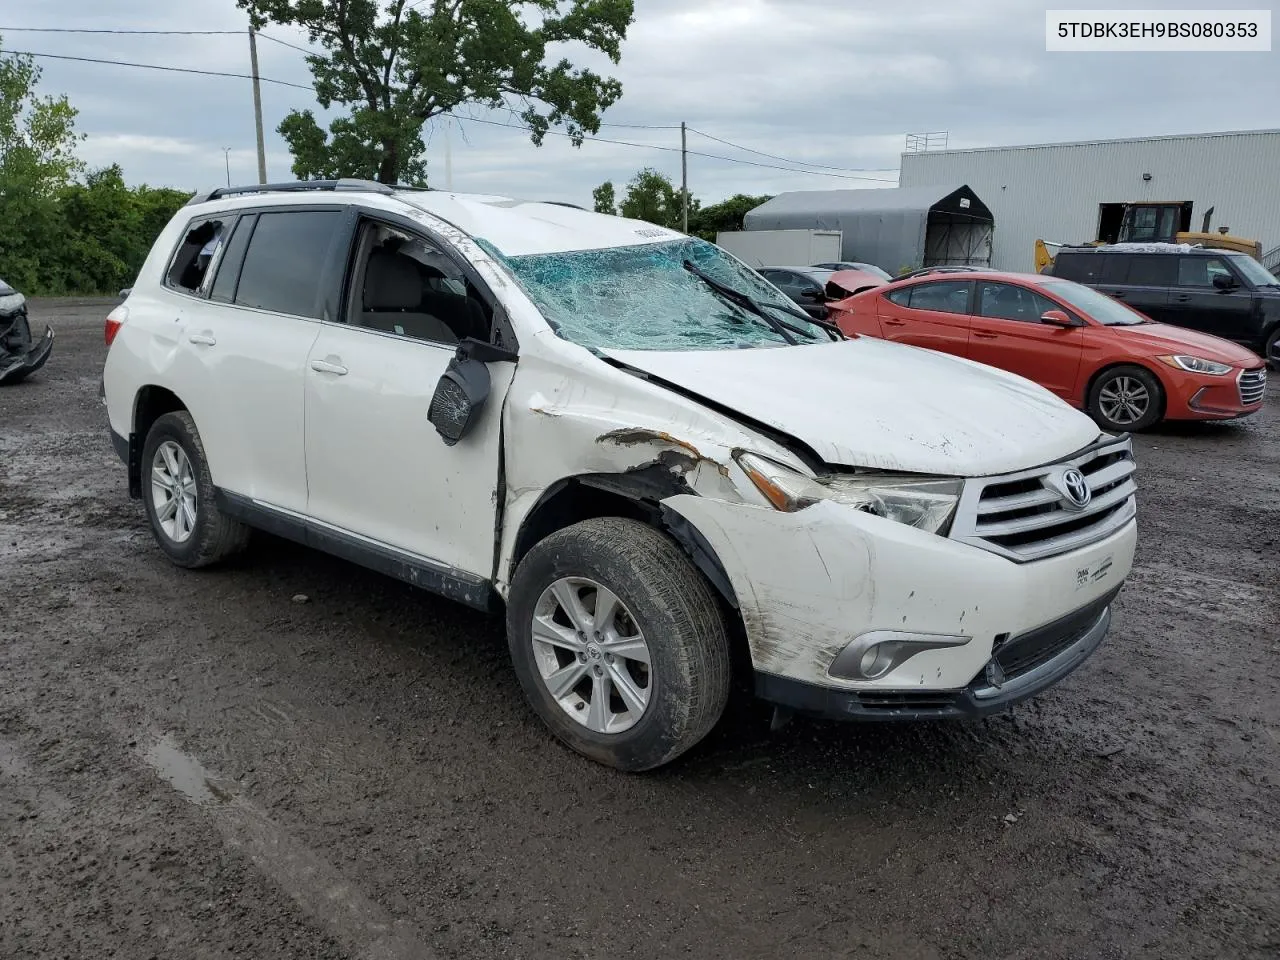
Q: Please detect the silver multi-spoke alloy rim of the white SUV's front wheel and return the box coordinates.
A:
[532,577,653,733]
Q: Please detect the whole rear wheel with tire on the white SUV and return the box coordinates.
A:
[142,410,250,570]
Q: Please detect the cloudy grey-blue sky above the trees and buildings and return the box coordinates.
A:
[0,0,1280,204]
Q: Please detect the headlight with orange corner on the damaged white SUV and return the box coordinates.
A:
[737,453,963,534]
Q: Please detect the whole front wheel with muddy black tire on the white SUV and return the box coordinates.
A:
[507,517,731,771]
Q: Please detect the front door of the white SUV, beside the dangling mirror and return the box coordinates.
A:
[305,220,515,579]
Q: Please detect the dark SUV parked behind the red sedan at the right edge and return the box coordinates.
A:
[1046,243,1280,366]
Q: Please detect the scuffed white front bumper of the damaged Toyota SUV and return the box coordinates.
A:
[664,495,1137,701]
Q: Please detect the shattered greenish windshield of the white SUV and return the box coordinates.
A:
[488,237,829,351]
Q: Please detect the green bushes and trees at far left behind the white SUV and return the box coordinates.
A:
[0,42,191,294]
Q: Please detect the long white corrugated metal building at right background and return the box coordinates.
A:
[900,131,1280,271]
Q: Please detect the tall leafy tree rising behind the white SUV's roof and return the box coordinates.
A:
[236,0,635,183]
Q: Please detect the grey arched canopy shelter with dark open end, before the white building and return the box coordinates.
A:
[742,186,996,273]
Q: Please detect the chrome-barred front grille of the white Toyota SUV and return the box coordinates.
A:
[951,436,1138,562]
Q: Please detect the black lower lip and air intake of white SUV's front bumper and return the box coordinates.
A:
[755,589,1119,721]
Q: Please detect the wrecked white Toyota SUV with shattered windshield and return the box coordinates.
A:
[104,180,1135,769]
